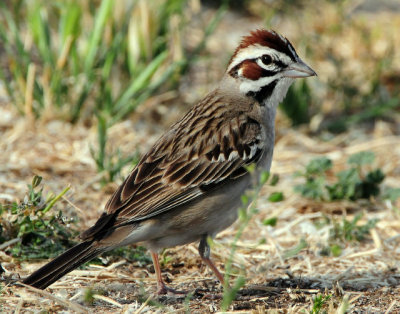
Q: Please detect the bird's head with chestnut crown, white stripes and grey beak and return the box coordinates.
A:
[226,29,317,105]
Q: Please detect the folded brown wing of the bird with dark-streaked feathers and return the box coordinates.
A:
[106,103,264,225]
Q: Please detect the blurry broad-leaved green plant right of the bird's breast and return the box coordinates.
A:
[295,152,395,201]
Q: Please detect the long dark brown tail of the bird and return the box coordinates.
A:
[23,241,106,289]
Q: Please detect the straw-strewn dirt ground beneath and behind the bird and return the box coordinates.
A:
[0,2,400,313]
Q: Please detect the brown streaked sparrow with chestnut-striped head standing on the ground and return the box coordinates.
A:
[23,28,317,294]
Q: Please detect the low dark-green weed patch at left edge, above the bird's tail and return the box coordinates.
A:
[0,176,77,259]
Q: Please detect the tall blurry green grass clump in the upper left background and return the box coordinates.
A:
[0,0,189,122]
